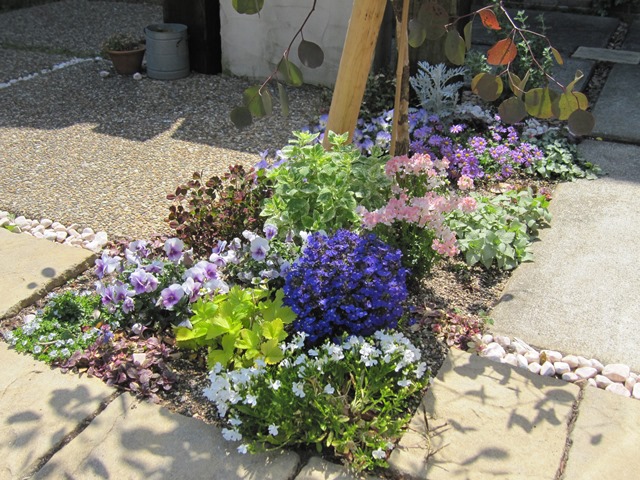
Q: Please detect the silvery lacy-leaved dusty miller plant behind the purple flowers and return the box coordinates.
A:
[409,62,466,117]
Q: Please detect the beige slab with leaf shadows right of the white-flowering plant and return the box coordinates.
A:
[389,350,579,480]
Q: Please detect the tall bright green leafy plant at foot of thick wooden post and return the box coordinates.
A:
[261,132,389,233]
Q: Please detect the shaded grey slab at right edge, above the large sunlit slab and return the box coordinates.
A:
[591,65,640,143]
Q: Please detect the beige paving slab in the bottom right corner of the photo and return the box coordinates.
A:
[563,388,640,480]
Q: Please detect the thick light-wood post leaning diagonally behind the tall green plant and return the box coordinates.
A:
[323,0,387,148]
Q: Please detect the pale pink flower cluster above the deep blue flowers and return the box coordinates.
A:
[361,154,476,257]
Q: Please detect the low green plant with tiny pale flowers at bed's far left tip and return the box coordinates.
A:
[3,291,105,363]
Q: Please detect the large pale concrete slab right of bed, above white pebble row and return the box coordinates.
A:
[491,141,640,372]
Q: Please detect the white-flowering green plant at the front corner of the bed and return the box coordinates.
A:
[204,331,429,470]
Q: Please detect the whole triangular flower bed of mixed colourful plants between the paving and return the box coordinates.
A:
[4,67,593,470]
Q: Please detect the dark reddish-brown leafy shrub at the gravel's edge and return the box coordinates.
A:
[167,165,271,256]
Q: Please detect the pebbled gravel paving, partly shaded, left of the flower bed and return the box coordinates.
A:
[0,0,328,239]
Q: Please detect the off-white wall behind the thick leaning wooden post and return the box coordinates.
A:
[220,0,353,86]
